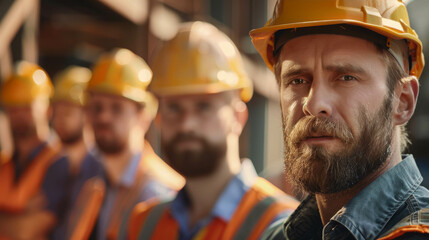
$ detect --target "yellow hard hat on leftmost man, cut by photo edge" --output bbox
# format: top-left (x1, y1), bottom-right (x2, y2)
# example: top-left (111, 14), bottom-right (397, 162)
top-left (0, 61), bottom-right (53, 106)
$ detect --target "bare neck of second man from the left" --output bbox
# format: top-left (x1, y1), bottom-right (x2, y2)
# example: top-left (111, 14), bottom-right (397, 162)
top-left (62, 138), bottom-right (88, 175)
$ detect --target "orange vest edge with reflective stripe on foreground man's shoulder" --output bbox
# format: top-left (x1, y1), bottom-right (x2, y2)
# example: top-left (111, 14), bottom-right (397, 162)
top-left (378, 208), bottom-right (429, 240)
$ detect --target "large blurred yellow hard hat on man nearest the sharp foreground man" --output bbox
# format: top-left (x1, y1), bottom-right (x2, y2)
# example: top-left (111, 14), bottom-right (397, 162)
top-left (150, 22), bottom-right (253, 102)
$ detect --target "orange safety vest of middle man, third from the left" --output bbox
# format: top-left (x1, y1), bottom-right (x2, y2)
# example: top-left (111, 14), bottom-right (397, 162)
top-left (67, 142), bottom-right (185, 240)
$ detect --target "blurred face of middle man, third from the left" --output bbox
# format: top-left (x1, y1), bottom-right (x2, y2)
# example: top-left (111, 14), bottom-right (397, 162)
top-left (88, 93), bottom-right (141, 154)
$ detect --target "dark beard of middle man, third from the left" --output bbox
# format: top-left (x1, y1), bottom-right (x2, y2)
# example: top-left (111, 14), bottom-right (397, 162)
top-left (94, 124), bottom-right (126, 154)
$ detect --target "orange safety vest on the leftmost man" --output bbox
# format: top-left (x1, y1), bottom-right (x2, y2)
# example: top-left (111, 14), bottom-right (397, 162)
top-left (0, 144), bottom-right (61, 212)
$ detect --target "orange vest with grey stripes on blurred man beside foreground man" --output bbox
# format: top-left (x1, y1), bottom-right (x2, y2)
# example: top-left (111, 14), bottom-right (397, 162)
top-left (129, 178), bottom-right (299, 240)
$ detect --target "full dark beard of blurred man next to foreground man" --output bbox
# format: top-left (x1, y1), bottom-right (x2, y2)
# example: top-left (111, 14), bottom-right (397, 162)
top-left (162, 133), bottom-right (226, 178)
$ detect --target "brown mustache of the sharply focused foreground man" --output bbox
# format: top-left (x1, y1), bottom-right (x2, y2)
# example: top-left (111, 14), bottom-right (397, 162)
top-left (289, 116), bottom-right (354, 144)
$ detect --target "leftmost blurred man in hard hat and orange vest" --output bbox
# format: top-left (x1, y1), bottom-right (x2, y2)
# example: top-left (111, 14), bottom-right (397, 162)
top-left (0, 61), bottom-right (68, 239)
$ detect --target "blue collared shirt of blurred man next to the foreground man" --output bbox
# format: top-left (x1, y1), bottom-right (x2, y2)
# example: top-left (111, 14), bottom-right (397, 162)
top-left (171, 159), bottom-right (290, 240)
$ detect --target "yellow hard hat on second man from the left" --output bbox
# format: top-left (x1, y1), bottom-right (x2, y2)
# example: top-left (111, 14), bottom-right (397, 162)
top-left (52, 66), bottom-right (91, 106)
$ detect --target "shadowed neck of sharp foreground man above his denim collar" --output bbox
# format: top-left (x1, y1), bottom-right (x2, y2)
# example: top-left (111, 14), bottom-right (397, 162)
top-left (316, 144), bottom-right (402, 225)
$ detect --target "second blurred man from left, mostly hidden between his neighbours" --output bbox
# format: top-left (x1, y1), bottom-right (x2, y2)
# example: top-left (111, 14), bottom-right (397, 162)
top-left (51, 66), bottom-right (104, 239)
